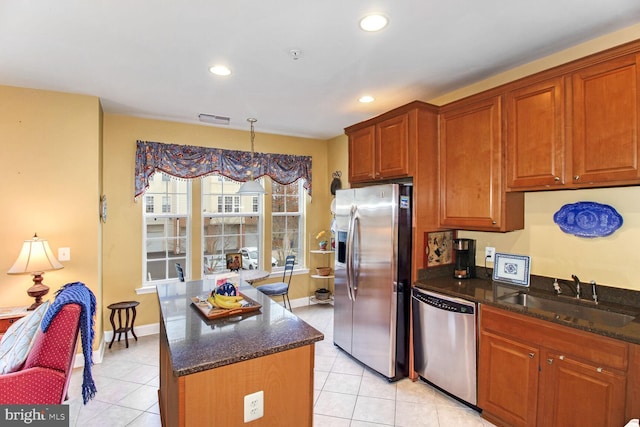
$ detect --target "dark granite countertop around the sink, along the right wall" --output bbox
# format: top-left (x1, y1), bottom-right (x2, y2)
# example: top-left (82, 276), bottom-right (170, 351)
top-left (414, 268), bottom-right (640, 344)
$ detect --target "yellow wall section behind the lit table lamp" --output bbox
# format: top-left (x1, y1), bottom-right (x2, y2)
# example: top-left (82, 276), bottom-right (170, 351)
top-left (0, 86), bottom-right (102, 342)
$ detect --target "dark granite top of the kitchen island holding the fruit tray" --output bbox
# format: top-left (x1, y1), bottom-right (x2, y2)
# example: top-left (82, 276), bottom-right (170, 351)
top-left (157, 280), bottom-right (324, 376)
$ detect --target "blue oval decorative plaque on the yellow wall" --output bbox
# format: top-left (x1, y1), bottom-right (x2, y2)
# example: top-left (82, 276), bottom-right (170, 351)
top-left (553, 202), bottom-right (622, 237)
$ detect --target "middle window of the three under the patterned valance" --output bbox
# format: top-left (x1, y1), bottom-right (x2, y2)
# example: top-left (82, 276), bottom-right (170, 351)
top-left (202, 175), bottom-right (263, 274)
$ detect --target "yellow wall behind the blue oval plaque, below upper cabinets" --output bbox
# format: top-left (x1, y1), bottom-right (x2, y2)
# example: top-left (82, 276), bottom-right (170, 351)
top-left (459, 187), bottom-right (640, 291)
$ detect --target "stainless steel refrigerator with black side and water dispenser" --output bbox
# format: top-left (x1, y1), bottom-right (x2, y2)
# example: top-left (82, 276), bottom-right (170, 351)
top-left (333, 184), bottom-right (412, 381)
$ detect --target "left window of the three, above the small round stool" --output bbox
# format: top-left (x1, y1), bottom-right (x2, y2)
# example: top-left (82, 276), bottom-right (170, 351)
top-left (143, 172), bottom-right (191, 283)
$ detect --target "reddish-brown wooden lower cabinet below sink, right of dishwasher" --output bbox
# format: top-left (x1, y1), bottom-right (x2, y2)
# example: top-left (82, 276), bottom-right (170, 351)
top-left (478, 306), bottom-right (637, 427)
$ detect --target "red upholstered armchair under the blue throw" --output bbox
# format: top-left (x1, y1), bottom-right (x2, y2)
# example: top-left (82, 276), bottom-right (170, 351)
top-left (0, 304), bottom-right (80, 405)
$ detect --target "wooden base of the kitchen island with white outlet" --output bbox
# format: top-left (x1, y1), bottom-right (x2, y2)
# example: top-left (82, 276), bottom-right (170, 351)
top-left (158, 332), bottom-right (314, 427)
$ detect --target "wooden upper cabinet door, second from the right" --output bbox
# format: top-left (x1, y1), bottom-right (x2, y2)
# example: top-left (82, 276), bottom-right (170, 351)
top-left (506, 77), bottom-right (566, 191)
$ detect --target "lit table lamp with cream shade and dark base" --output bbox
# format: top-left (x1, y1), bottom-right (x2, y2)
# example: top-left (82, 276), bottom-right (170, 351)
top-left (7, 234), bottom-right (64, 310)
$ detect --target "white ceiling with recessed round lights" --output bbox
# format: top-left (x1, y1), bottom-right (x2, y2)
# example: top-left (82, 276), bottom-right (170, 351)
top-left (0, 0), bottom-right (640, 139)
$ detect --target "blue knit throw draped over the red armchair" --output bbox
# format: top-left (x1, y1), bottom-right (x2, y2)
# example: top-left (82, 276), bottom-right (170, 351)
top-left (41, 282), bottom-right (97, 405)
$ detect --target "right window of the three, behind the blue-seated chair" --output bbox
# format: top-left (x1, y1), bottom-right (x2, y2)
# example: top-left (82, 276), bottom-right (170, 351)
top-left (271, 179), bottom-right (305, 267)
